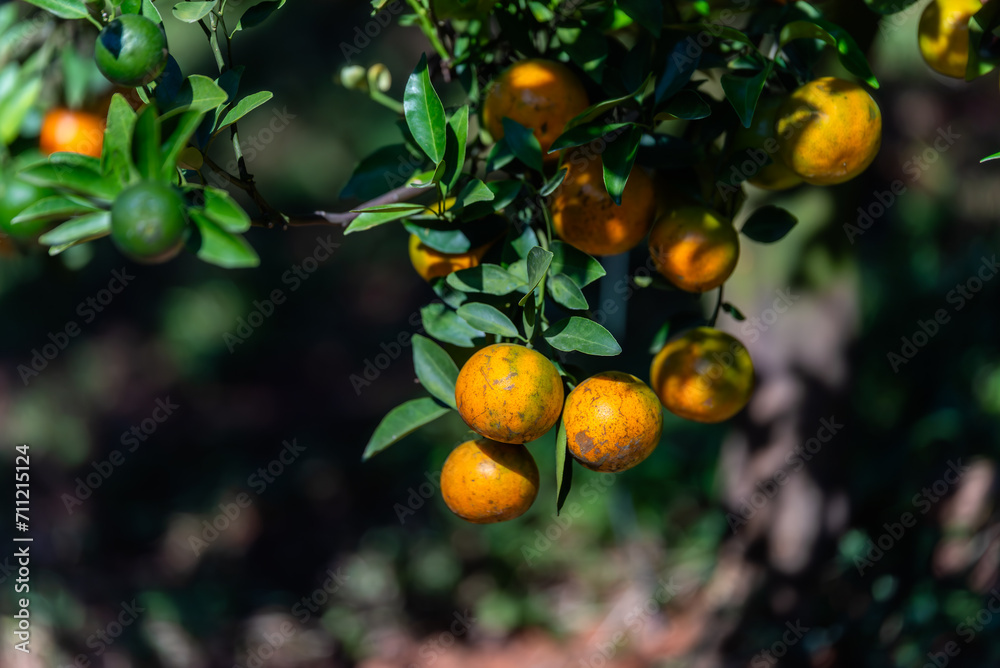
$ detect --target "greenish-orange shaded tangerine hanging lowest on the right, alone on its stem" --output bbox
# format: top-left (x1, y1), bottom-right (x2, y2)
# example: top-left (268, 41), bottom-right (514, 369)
top-left (649, 327), bottom-right (754, 422)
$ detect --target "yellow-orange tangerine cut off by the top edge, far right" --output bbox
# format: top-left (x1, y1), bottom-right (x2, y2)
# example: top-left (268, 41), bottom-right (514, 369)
top-left (917, 0), bottom-right (983, 79)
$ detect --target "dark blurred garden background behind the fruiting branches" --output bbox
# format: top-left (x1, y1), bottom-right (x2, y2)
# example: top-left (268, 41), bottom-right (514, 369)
top-left (0, 0), bottom-right (1000, 668)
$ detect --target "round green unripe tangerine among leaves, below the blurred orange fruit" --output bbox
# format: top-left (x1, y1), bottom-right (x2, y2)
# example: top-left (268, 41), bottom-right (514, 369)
top-left (111, 181), bottom-right (187, 264)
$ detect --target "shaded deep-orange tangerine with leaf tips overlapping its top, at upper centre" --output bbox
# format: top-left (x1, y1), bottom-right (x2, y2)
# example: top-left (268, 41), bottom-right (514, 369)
top-left (549, 150), bottom-right (657, 255)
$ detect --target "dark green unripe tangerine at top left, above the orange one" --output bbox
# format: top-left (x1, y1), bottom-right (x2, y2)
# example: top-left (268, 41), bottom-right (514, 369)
top-left (94, 14), bottom-right (168, 88)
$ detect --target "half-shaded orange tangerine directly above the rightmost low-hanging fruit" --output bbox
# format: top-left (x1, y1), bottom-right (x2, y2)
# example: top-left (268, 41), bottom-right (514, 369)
top-left (649, 205), bottom-right (740, 292)
